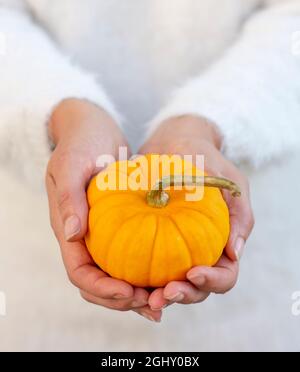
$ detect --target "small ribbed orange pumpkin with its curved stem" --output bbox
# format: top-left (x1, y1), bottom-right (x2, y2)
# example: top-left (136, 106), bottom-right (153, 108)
top-left (85, 155), bottom-right (240, 287)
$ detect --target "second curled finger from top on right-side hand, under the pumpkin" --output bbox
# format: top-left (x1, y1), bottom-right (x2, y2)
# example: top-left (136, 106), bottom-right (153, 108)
top-left (164, 282), bottom-right (209, 305)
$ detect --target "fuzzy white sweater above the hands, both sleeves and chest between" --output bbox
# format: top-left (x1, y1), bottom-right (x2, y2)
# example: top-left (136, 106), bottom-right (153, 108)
top-left (0, 0), bottom-right (300, 185)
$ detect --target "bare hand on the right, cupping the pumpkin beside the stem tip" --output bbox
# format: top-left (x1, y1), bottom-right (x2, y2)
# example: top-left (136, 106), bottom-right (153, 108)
top-left (140, 116), bottom-right (254, 310)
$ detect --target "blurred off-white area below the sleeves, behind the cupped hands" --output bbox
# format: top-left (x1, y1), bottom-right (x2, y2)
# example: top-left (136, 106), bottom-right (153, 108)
top-left (0, 152), bottom-right (300, 351)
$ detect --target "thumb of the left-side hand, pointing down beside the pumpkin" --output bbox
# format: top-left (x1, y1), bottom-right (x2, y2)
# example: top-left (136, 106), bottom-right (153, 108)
top-left (49, 153), bottom-right (92, 241)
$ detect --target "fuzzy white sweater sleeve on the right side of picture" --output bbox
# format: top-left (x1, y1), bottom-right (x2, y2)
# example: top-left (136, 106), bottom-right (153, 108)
top-left (151, 1), bottom-right (300, 167)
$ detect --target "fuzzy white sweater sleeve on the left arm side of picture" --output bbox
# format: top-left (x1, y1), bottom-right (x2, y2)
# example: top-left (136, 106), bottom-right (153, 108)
top-left (0, 4), bottom-right (119, 185)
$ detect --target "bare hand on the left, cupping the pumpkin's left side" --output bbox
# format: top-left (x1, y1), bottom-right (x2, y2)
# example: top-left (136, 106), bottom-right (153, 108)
top-left (46, 99), bottom-right (161, 321)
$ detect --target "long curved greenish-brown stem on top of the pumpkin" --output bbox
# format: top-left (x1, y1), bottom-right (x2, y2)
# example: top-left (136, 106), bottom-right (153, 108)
top-left (147, 176), bottom-right (242, 208)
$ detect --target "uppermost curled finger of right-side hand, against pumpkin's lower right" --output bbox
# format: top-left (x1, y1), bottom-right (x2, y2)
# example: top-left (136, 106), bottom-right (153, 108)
top-left (187, 256), bottom-right (239, 294)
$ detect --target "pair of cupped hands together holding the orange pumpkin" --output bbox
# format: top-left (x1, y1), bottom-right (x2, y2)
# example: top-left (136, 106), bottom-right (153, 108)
top-left (46, 99), bottom-right (254, 322)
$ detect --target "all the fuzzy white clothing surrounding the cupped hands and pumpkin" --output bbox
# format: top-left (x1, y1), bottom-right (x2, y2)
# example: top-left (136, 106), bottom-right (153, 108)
top-left (0, 0), bottom-right (300, 351)
